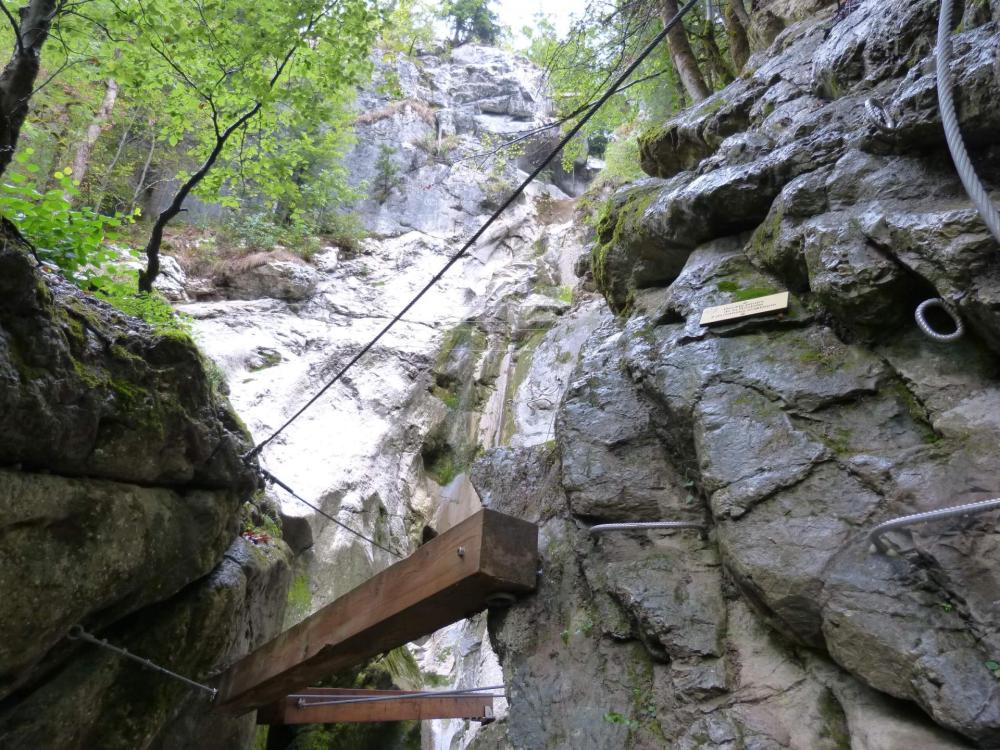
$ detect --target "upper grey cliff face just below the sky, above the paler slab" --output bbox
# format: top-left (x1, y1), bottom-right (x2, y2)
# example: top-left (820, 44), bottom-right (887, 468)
top-left (345, 45), bottom-right (564, 237)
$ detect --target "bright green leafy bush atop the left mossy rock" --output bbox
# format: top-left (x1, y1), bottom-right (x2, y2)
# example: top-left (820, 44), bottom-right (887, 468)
top-left (0, 148), bottom-right (131, 287)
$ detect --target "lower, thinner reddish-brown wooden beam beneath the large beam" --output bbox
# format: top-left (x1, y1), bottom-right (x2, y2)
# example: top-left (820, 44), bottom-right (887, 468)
top-left (257, 688), bottom-right (493, 726)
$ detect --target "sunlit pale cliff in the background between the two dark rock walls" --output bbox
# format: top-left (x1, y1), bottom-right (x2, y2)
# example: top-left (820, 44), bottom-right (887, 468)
top-left (177, 39), bottom-right (592, 750)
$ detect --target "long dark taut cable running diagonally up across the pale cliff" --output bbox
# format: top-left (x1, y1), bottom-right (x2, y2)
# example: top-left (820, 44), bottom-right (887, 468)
top-left (243, 0), bottom-right (700, 463)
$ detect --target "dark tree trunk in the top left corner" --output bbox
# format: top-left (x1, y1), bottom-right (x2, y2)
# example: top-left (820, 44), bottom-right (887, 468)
top-left (0, 0), bottom-right (58, 180)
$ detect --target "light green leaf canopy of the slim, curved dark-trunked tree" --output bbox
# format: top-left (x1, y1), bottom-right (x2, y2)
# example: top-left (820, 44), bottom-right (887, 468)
top-left (107, 0), bottom-right (380, 221)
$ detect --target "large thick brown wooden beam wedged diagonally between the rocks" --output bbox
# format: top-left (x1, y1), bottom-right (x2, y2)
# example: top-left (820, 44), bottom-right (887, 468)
top-left (218, 509), bottom-right (538, 714)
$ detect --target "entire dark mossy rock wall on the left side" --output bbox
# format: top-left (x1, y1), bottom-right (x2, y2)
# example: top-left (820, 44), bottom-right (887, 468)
top-left (0, 242), bottom-right (289, 750)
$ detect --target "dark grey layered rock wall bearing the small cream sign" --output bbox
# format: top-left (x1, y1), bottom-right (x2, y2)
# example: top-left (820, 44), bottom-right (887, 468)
top-left (473, 0), bottom-right (1000, 750)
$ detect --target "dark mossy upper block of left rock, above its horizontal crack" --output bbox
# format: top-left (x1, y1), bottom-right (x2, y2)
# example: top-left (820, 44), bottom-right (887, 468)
top-left (0, 246), bottom-right (255, 491)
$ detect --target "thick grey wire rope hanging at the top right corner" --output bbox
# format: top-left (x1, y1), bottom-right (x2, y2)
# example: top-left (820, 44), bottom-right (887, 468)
top-left (934, 0), bottom-right (1000, 242)
